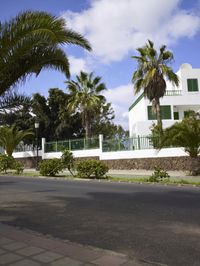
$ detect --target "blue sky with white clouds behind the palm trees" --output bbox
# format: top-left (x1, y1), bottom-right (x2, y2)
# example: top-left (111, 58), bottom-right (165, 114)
top-left (0, 0), bottom-right (200, 129)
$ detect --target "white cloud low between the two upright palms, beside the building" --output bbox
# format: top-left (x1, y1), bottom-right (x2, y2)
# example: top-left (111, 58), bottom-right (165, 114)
top-left (104, 84), bottom-right (134, 129)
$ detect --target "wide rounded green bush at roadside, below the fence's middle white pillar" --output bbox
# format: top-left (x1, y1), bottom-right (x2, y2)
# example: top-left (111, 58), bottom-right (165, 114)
top-left (76, 160), bottom-right (109, 179)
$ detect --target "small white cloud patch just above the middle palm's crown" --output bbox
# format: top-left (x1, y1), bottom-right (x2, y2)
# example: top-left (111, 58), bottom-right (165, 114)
top-left (68, 56), bottom-right (90, 75)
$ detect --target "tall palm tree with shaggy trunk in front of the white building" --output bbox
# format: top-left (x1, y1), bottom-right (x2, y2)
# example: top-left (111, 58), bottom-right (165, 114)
top-left (132, 40), bottom-right (179, 130)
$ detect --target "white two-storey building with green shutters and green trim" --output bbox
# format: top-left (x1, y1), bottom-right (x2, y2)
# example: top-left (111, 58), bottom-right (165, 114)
top-left (129, 64), bottom-right (200, 137)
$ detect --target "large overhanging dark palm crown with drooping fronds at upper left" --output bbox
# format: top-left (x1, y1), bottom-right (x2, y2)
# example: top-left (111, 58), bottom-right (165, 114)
top-left (0, 11), bottom-right (91, 95)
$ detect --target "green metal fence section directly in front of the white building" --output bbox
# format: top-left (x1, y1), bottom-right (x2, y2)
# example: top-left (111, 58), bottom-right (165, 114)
top-left (102, 136), bottom-right (159, 152)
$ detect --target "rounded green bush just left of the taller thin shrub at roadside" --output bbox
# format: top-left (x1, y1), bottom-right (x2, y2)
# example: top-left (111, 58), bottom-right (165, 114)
top-left (39, 158), bottom-right (63, 176)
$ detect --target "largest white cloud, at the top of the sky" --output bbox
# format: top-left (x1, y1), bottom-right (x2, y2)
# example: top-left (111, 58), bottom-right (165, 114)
top-left (62, 0), bottom-right (200, 62)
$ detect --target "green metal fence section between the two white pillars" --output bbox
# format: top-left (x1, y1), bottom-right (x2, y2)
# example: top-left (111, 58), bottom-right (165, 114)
top-left (44, 138), bottom-right (99, 152)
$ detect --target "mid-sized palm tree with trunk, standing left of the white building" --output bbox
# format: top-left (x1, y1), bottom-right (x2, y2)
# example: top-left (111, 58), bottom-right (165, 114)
top-left (66, 71), bottom-right (106, 138)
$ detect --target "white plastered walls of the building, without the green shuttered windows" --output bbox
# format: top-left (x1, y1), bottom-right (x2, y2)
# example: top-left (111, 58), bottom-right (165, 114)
top-left (129, 64), bottom-right (200, 137)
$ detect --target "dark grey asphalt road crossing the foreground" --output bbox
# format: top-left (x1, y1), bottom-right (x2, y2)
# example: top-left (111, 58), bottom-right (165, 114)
top-left (0, 177), bottom-right (200, 266)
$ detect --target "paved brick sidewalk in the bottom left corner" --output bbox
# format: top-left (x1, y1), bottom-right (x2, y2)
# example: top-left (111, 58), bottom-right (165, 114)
top-left (0, 223), bottom-right (142, 266)
